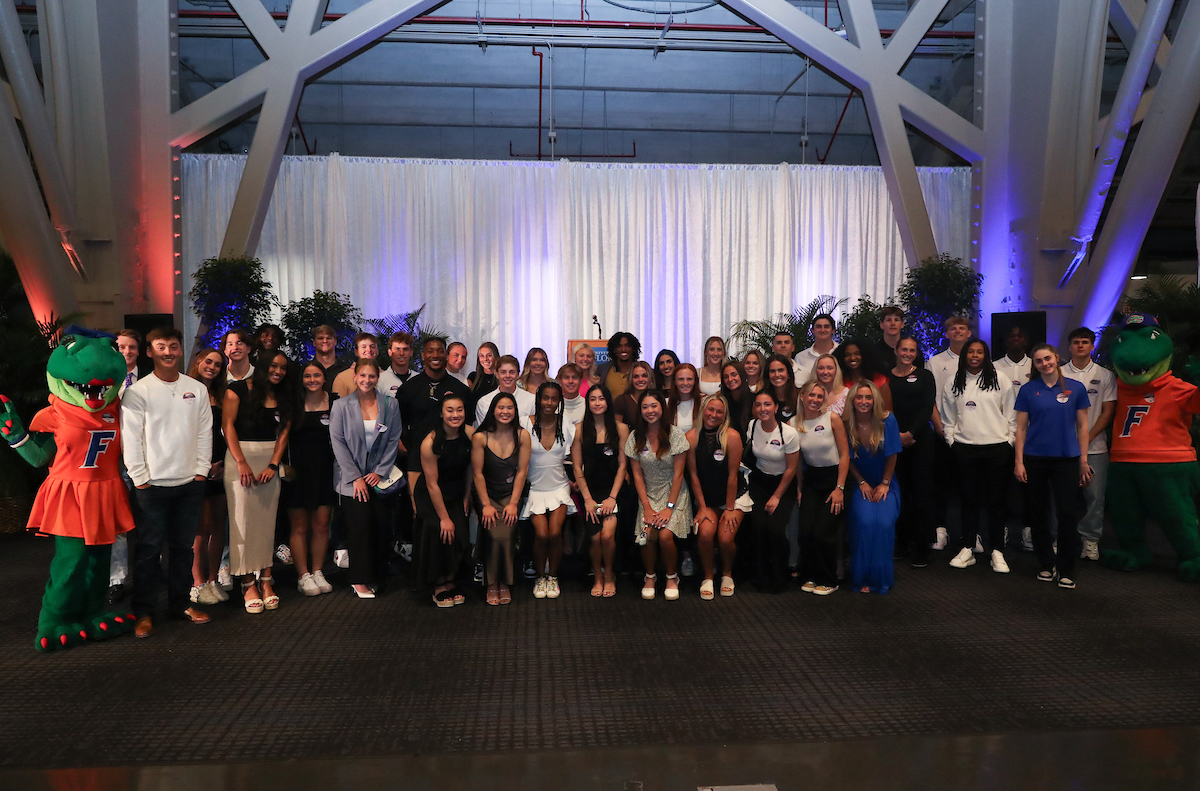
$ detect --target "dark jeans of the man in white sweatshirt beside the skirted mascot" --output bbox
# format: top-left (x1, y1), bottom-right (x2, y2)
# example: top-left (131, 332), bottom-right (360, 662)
top-left (131, 480), bottom-right (204, 617)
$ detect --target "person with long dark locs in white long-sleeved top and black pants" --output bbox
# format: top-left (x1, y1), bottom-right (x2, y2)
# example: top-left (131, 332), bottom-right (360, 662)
top-left (937, 337), bottom-right (1016, 574)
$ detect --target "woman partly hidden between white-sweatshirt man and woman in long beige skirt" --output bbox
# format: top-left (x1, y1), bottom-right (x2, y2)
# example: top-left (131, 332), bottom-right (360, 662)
top-left (187, 349), bottom-right (229, 604)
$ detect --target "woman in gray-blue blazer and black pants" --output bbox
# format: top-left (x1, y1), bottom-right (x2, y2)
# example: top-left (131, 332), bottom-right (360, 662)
top-left (329, 359), bottom-right (400, 599)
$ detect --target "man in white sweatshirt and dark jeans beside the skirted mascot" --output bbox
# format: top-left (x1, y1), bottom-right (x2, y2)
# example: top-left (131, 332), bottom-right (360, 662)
top-left (121, 328), bottom-right (212, 637)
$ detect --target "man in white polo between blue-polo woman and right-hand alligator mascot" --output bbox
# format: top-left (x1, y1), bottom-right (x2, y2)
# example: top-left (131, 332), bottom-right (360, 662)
top-left (1062, 326), bottom-right (1117, 561)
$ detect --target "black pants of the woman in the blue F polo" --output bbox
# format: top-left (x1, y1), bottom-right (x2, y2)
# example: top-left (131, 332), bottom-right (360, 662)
top-left (1025, 456), bottom-right (1087, 577)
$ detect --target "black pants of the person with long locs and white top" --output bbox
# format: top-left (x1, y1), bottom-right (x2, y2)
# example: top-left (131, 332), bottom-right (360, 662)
top-left (955, 442), bottom-right (1013, 552)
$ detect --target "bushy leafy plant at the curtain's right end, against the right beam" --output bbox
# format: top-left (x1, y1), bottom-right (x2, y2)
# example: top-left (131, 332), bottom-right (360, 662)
top-left (896, 253), bottom-right (983, 352)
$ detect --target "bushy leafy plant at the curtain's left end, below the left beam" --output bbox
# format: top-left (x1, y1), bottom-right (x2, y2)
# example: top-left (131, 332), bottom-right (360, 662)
top-left (187, 256), bottom-right (280, 347)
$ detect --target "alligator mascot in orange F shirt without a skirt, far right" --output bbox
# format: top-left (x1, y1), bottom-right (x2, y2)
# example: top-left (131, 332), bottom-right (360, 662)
top-left (1100, 313), bottom-right (1200, 582)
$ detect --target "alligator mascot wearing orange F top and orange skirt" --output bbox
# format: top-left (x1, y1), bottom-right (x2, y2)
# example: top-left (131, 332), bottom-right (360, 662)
top-left (0, 326), bottom-right (134, 651)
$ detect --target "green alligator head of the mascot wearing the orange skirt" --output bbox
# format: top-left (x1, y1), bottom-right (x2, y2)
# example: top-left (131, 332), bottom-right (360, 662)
top-left (46, 326), bottom-right (125, 412)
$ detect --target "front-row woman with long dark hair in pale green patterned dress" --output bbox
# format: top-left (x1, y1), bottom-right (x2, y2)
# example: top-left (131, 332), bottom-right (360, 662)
top-left (625, 390), bottom-right (691, 601)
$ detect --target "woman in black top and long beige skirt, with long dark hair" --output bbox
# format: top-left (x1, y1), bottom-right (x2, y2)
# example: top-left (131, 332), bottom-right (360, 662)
top-left (221, 352), bottom-right (294, 613)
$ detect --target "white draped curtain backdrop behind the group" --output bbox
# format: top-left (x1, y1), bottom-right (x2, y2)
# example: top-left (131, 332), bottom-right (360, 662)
top-left (182, 154), bottom-right (971, 367)
